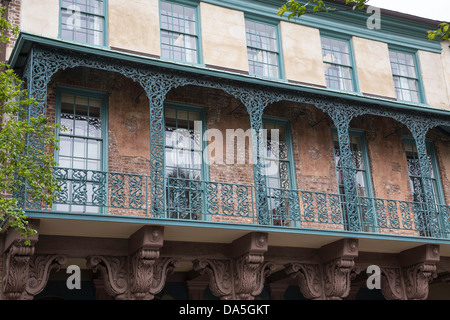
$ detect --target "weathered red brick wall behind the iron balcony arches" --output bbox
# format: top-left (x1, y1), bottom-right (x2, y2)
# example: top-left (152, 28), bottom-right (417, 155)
top-left (44, 68), bottom-right (450, 232)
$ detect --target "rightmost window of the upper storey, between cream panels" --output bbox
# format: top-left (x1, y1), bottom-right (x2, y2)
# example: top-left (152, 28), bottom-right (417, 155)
top-left (389, 50), bottom-right (422, 103)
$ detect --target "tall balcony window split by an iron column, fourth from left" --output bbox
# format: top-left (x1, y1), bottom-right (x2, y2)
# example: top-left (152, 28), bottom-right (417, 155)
top-left (333, 130), bottom-right (375, 231)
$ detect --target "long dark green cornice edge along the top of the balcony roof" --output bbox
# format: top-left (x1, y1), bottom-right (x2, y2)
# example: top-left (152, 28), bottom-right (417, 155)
top-left (9, 32), bottom-right (450, 116)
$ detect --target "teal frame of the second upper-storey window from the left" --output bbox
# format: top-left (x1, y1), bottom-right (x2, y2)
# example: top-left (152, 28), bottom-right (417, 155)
top-left (158, 0), bottom-right (203, 66)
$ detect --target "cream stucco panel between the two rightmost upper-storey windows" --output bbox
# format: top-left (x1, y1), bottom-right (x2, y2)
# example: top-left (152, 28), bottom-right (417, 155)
top-left (352, 37), bottom-right (396, 98)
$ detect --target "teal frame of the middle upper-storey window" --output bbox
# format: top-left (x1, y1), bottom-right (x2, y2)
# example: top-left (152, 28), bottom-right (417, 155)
top-left (244, 13), bottom-right (285, 81)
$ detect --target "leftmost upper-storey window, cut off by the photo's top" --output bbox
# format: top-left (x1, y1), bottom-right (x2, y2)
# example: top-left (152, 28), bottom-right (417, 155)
top-left (60, 0), bottom-right (106, 46)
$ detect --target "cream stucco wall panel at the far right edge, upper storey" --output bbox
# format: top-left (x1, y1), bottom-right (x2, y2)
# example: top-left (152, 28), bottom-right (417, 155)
top-left (418, 51), bottom-right (450, 109)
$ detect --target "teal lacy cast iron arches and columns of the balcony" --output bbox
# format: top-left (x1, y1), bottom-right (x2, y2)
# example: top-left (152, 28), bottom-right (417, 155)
top-left (23, 45), bottom-right (450, 235)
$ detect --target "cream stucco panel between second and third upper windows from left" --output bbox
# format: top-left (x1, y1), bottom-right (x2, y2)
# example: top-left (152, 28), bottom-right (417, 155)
top-left (200, 2), bottom-right (249, 72)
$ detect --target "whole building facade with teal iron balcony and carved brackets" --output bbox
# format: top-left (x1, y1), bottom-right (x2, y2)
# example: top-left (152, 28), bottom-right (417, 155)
top-left (0, 0), bottom-right (450, 300)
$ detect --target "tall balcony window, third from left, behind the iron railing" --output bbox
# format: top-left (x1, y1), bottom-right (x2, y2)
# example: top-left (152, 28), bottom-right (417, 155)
top-left (263, 119), bottom-right (298, 225)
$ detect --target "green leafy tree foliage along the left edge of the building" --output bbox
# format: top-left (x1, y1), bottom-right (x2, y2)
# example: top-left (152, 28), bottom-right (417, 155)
top-left (0, 8), bottom-right (59, 244)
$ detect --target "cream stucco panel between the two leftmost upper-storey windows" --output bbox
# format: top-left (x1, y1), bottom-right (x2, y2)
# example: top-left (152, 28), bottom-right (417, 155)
top-left (108, 0), bottom-right (161, 56)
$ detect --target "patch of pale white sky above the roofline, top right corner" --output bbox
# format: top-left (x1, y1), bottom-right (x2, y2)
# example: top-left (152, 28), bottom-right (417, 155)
top-left (367, 0), bottom-right (450, 22)
